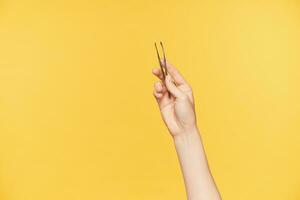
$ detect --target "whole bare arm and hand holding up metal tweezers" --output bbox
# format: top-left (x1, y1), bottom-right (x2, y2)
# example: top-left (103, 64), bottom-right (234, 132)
top-left (152, 63), bottom-right (221, 200)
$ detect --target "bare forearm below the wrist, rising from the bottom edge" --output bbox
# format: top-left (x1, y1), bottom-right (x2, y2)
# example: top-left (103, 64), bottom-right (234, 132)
top-left (174, 130), bottom-right (221, 200)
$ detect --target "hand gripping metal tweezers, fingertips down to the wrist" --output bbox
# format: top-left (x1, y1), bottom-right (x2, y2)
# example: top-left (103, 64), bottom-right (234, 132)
top-left (152, 63), bottom-right (197, 137)
